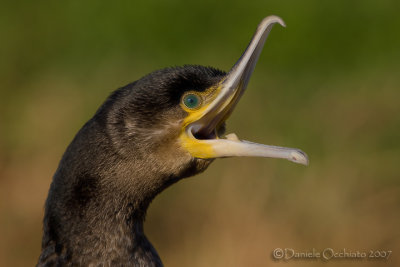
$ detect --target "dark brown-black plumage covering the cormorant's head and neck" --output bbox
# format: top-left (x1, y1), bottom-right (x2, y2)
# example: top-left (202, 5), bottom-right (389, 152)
top-left (39, 66), bottom-right (225, 266)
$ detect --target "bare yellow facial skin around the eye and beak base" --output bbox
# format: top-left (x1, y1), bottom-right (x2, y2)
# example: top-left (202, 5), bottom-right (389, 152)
top-left (179, 86), bottom-right (221, 159)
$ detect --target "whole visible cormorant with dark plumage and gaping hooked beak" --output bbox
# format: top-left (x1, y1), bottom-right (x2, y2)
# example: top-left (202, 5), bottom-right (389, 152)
top-left (38, 16), bottom-right (308, 266)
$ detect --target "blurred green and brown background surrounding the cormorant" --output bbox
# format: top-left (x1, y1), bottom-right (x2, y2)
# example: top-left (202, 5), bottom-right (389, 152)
top-left (0, 0), bottom-right (400, 266)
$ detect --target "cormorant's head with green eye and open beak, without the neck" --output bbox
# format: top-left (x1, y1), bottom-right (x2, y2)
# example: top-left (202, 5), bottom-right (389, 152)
top-left (98, 16), bottom-right (308, 181)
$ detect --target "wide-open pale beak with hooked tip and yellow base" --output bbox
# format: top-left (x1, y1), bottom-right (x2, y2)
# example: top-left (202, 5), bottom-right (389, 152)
top-left (182, 16), bottom-right (308, 165)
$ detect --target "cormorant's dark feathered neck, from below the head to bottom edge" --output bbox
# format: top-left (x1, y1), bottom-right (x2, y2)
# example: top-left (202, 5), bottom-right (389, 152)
top-left (39, 120), bottom-right (185, 266)
